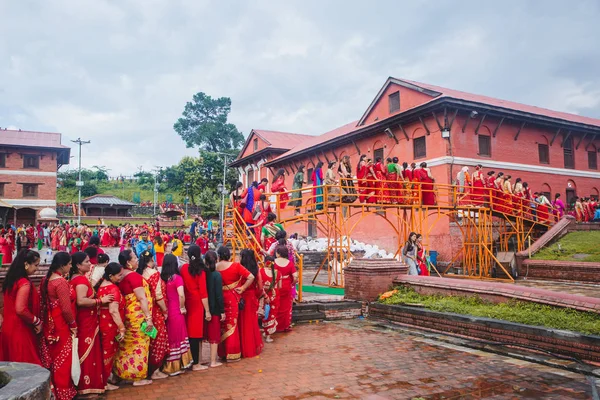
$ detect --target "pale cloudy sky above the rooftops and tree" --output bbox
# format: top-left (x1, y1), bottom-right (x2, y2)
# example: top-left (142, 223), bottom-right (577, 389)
top-left (0, 0), bottom-right (600, 175)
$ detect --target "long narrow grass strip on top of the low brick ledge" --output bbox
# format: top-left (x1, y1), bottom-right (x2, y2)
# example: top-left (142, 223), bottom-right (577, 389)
top-left (379, 287), bottom-right (600, 335)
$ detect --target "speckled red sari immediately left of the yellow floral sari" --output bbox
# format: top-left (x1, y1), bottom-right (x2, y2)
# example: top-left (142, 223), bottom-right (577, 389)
top-left (97, 283), bottom-right (125, 387)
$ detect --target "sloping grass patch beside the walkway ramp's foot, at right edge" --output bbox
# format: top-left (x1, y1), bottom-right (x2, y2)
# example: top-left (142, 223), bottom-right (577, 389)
top-left (531, 231), bottom-right (600, 262)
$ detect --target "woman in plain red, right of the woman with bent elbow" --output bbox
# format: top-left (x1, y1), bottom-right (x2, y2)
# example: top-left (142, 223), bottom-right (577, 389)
top-left (239, 249), bottom-right (264, 358)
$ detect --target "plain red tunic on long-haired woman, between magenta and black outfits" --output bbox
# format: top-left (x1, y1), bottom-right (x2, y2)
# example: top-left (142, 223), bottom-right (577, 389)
top-left (180, 264), bottom-right (208, 339)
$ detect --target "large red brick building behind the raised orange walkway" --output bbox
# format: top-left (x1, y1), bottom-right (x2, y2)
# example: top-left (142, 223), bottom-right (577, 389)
top-left (235, 78), bottom-right (600, 258)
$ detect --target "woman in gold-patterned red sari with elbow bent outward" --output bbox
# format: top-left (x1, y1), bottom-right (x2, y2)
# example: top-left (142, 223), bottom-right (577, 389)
top-left (217, 246), bottom-right (254, 362)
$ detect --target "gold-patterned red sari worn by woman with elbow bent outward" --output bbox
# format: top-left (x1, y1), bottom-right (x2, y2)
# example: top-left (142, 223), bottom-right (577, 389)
top-left (219, 262), bottom-right (250, 361)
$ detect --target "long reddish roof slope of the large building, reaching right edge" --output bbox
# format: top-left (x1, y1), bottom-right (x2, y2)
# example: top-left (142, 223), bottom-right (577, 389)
top-left (400, 78), bottom-right (600, 131)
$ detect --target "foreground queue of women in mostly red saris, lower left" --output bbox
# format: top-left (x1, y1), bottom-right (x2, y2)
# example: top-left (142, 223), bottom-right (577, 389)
top-left (0, 233), bottom-right (297, 400)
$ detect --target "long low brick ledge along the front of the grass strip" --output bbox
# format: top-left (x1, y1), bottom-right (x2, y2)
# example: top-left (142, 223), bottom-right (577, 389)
top-left (369, 303), bottom-right (600, 363)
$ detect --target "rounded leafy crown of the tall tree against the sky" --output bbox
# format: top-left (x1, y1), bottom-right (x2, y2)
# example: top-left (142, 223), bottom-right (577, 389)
top-left (173, 92), bottom-right (244, 152)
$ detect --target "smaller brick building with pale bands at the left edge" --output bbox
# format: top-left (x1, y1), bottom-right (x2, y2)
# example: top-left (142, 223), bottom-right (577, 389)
top-left (0, 129), bottom-right (71, 224)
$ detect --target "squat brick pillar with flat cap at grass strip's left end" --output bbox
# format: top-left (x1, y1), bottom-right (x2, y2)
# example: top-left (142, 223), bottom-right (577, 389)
top-left (344, 259), bottom-right (408, 301)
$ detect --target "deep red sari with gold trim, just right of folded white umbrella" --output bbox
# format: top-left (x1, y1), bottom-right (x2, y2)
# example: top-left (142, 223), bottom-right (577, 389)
top-left (70, 276), bottom-right (106, 395)
